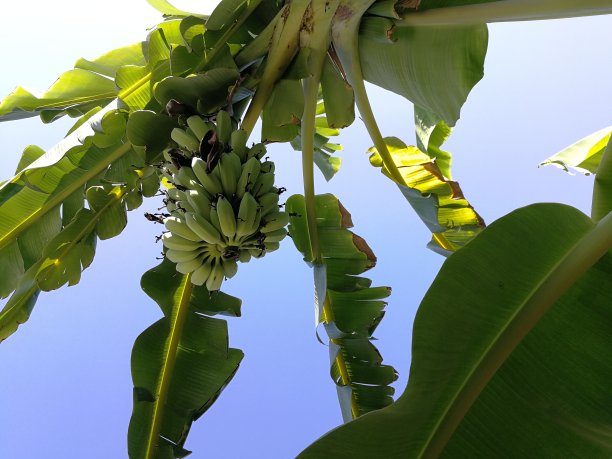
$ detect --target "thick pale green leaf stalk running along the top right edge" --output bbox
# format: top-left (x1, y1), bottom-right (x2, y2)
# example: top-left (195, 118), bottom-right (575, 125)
top-left (395, 0), bottom-right (612, 26)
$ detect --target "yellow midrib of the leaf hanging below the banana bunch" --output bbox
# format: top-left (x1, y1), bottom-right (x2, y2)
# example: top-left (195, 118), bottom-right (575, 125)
top-left (145, 274), bottom-right (193, 459)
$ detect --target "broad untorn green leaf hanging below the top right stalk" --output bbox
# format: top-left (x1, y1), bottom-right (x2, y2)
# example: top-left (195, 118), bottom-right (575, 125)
top-left (359, 18), bottom-right (488, 126)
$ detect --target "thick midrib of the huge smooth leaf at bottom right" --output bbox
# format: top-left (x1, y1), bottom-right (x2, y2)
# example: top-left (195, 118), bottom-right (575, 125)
top-left (415, 212), bottom-right (612, 458)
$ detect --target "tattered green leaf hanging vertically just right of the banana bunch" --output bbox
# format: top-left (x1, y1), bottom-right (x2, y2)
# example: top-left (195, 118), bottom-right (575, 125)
top-left (286, 194), bottom-right (397, 421)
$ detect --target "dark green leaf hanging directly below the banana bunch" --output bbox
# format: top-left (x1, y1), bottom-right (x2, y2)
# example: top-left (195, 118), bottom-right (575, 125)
top-left (128, 259), bottom-right (243, 459)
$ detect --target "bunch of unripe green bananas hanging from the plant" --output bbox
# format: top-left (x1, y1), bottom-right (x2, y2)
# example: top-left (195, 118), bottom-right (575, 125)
top-left (161, 111), bottom-right (289, 291)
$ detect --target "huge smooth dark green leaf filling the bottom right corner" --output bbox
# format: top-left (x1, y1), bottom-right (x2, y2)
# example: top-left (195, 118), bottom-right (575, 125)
top-left (300, 204), bottom-right (612, 458)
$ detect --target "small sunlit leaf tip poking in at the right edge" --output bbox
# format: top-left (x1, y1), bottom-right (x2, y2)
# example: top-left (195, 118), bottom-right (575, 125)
top-left (540, 126), bottom-right (612, 175)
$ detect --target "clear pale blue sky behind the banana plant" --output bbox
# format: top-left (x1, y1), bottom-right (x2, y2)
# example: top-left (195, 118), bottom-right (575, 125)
top-left (0, 0), bottom-right (612, 459)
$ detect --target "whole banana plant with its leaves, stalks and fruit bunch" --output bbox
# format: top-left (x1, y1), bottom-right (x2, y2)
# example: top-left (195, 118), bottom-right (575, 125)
top-left (0, 0), bottom-right (612, 459)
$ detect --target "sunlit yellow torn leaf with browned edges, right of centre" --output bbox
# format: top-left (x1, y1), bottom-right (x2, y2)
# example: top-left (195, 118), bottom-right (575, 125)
top-left (369, 137), bottom-right (485, 255)
